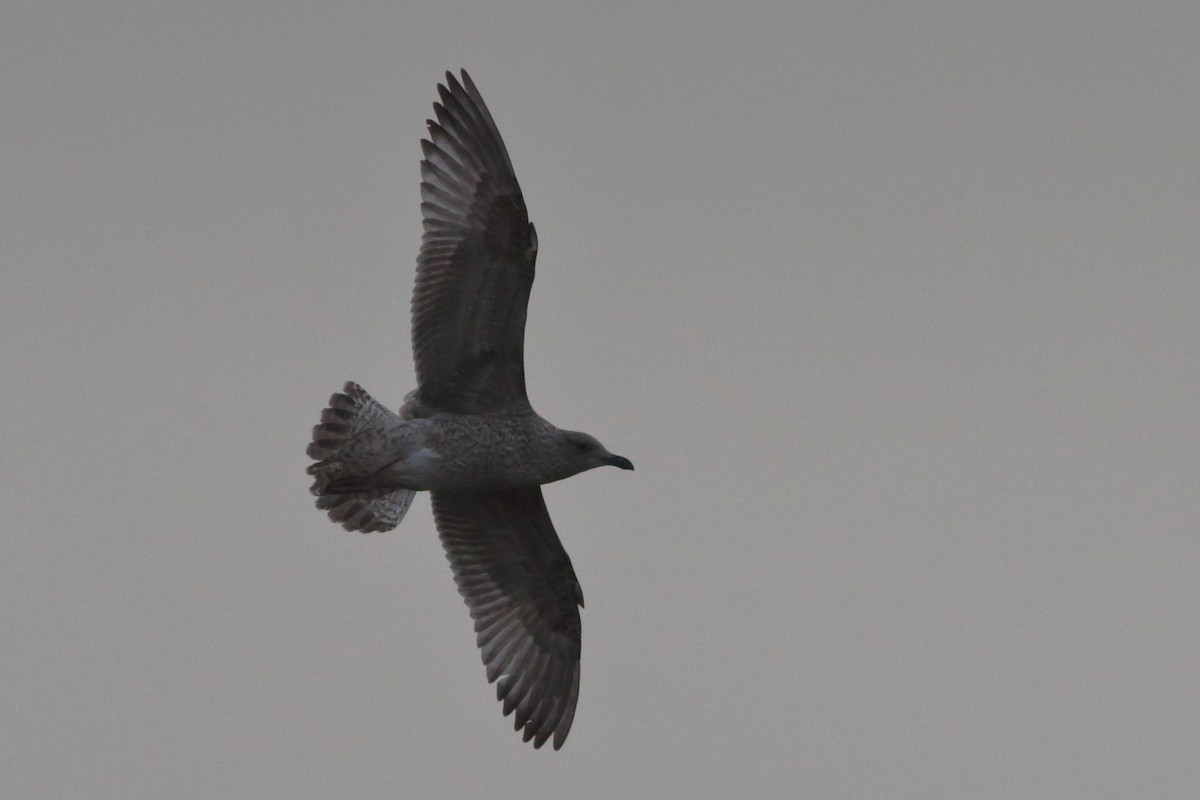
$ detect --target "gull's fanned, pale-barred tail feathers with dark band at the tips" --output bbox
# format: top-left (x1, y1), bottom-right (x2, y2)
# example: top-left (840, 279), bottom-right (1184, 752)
top-left (307, 383), bottom-right (415, 533)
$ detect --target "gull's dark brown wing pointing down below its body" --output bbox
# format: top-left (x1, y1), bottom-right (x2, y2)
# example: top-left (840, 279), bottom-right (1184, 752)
top-left (432, 487), bottom-right (583, 750)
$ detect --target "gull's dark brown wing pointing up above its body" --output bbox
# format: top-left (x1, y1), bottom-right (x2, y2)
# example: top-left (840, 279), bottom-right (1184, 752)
top-left (413, 71), bottom-right (538, 414)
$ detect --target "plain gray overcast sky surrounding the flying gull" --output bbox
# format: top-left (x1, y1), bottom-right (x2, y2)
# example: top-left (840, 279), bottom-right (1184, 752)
top-left (0, 0), bottom-right (1200, 800)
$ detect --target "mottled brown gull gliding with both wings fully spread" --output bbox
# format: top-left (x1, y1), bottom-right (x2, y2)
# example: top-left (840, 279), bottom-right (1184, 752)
top-left (307, 71), bottom-right (634, 750)
